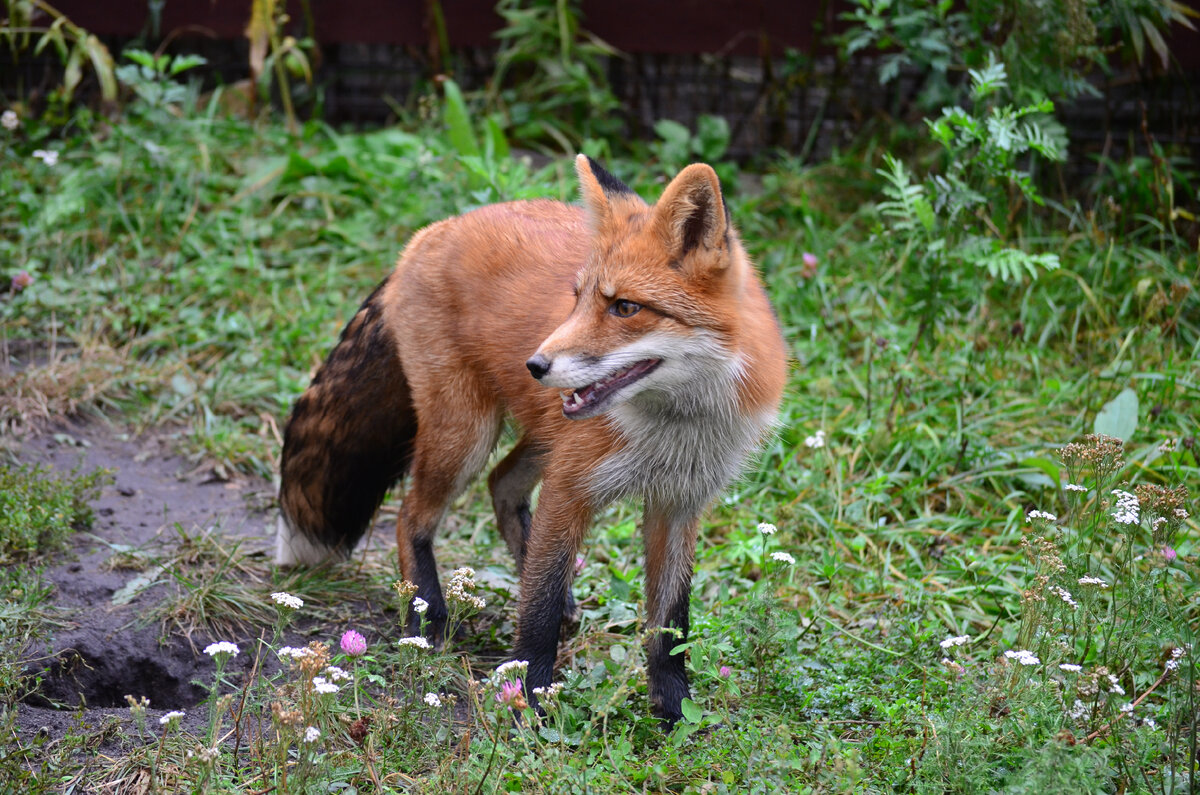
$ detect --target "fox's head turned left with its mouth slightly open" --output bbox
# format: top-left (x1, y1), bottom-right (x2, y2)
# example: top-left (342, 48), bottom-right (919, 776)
top-left (526, 155), bottom-right (749, 419)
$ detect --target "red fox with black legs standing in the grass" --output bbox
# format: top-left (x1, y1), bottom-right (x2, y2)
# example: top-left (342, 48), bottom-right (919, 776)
top-left (275, 155), bottom-right (787, 725)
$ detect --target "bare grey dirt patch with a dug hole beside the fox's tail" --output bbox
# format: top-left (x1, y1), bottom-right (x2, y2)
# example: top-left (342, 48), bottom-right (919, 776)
top-left (13, 423), bottom-right (274, 747)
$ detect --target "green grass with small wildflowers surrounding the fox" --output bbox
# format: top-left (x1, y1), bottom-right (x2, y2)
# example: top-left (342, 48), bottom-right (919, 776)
top-left (0, 63), bottom-right (1200, 793)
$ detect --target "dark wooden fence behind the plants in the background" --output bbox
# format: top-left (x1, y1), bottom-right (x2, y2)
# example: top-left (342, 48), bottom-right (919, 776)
top-left (0, 0), bottom-right (1200, 163)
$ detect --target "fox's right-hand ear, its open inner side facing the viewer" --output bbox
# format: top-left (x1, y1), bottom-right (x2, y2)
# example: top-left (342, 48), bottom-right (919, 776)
top-left (654, 163), bottom-right (728, 257)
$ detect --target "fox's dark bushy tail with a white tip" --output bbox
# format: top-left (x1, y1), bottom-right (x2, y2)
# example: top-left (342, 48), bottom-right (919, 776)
top-left (275, 281), bottom-right (416, 566)
